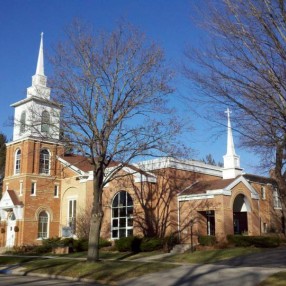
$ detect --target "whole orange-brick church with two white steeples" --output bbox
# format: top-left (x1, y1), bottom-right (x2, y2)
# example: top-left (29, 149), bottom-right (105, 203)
top-left (0, 35), bottom-right (282, 247)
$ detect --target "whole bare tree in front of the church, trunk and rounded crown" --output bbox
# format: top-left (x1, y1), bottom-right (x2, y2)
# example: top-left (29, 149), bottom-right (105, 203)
top-left (52, 22), bottom-right (185, 262)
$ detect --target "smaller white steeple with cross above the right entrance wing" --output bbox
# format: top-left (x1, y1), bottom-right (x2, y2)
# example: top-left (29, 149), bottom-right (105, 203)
top-left (222, 108), bottom-right (242, 179)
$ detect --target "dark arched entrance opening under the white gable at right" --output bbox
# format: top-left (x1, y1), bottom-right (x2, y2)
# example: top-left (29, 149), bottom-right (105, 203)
top-left (233, 194), bottom-right (251, 234)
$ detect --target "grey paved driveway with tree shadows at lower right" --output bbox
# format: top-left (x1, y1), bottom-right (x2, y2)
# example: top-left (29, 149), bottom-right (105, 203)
top-left (120, 248), bottom-right (286, 286)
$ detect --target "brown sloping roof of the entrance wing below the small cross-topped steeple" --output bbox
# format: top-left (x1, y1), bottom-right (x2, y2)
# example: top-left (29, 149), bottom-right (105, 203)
top-left (180, 178), bottom-right (236, 196)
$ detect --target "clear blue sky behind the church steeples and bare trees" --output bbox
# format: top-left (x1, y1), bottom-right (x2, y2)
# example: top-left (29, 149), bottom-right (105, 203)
top-left (0, 0), bottom-right (258, 173)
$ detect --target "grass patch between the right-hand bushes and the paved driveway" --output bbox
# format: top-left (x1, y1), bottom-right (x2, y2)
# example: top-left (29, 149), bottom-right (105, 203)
top-left (159, 247), bottom-right (263, 264)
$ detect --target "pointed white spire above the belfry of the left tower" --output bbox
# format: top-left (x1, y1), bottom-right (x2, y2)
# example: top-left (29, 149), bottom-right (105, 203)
top-left (27, 32), bottom-right (51, 100)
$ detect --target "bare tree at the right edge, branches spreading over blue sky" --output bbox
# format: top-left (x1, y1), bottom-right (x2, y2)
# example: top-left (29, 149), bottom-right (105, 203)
top-left (185, 0), bottom-right (286, 232)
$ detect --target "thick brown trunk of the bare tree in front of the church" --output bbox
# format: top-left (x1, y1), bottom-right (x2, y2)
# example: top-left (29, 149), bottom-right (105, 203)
top-left (87, 169), bottom-right (104, 262)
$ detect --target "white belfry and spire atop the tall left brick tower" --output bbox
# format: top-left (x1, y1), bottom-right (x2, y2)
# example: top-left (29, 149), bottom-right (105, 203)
top-left (11, 33), bottom-right (61, 141)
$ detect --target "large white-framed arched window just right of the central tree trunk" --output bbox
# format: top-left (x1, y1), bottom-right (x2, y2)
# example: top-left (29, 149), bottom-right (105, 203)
top-left (111, 191), bottom-right (133, 239)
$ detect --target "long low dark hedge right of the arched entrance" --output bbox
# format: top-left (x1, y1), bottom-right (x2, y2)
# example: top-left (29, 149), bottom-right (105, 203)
top-left (227, 235), bottom-right (281, 248)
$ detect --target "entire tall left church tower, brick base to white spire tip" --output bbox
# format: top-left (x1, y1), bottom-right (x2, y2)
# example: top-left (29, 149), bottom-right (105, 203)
top-left (0, 33), bottom-right (64, 247)
